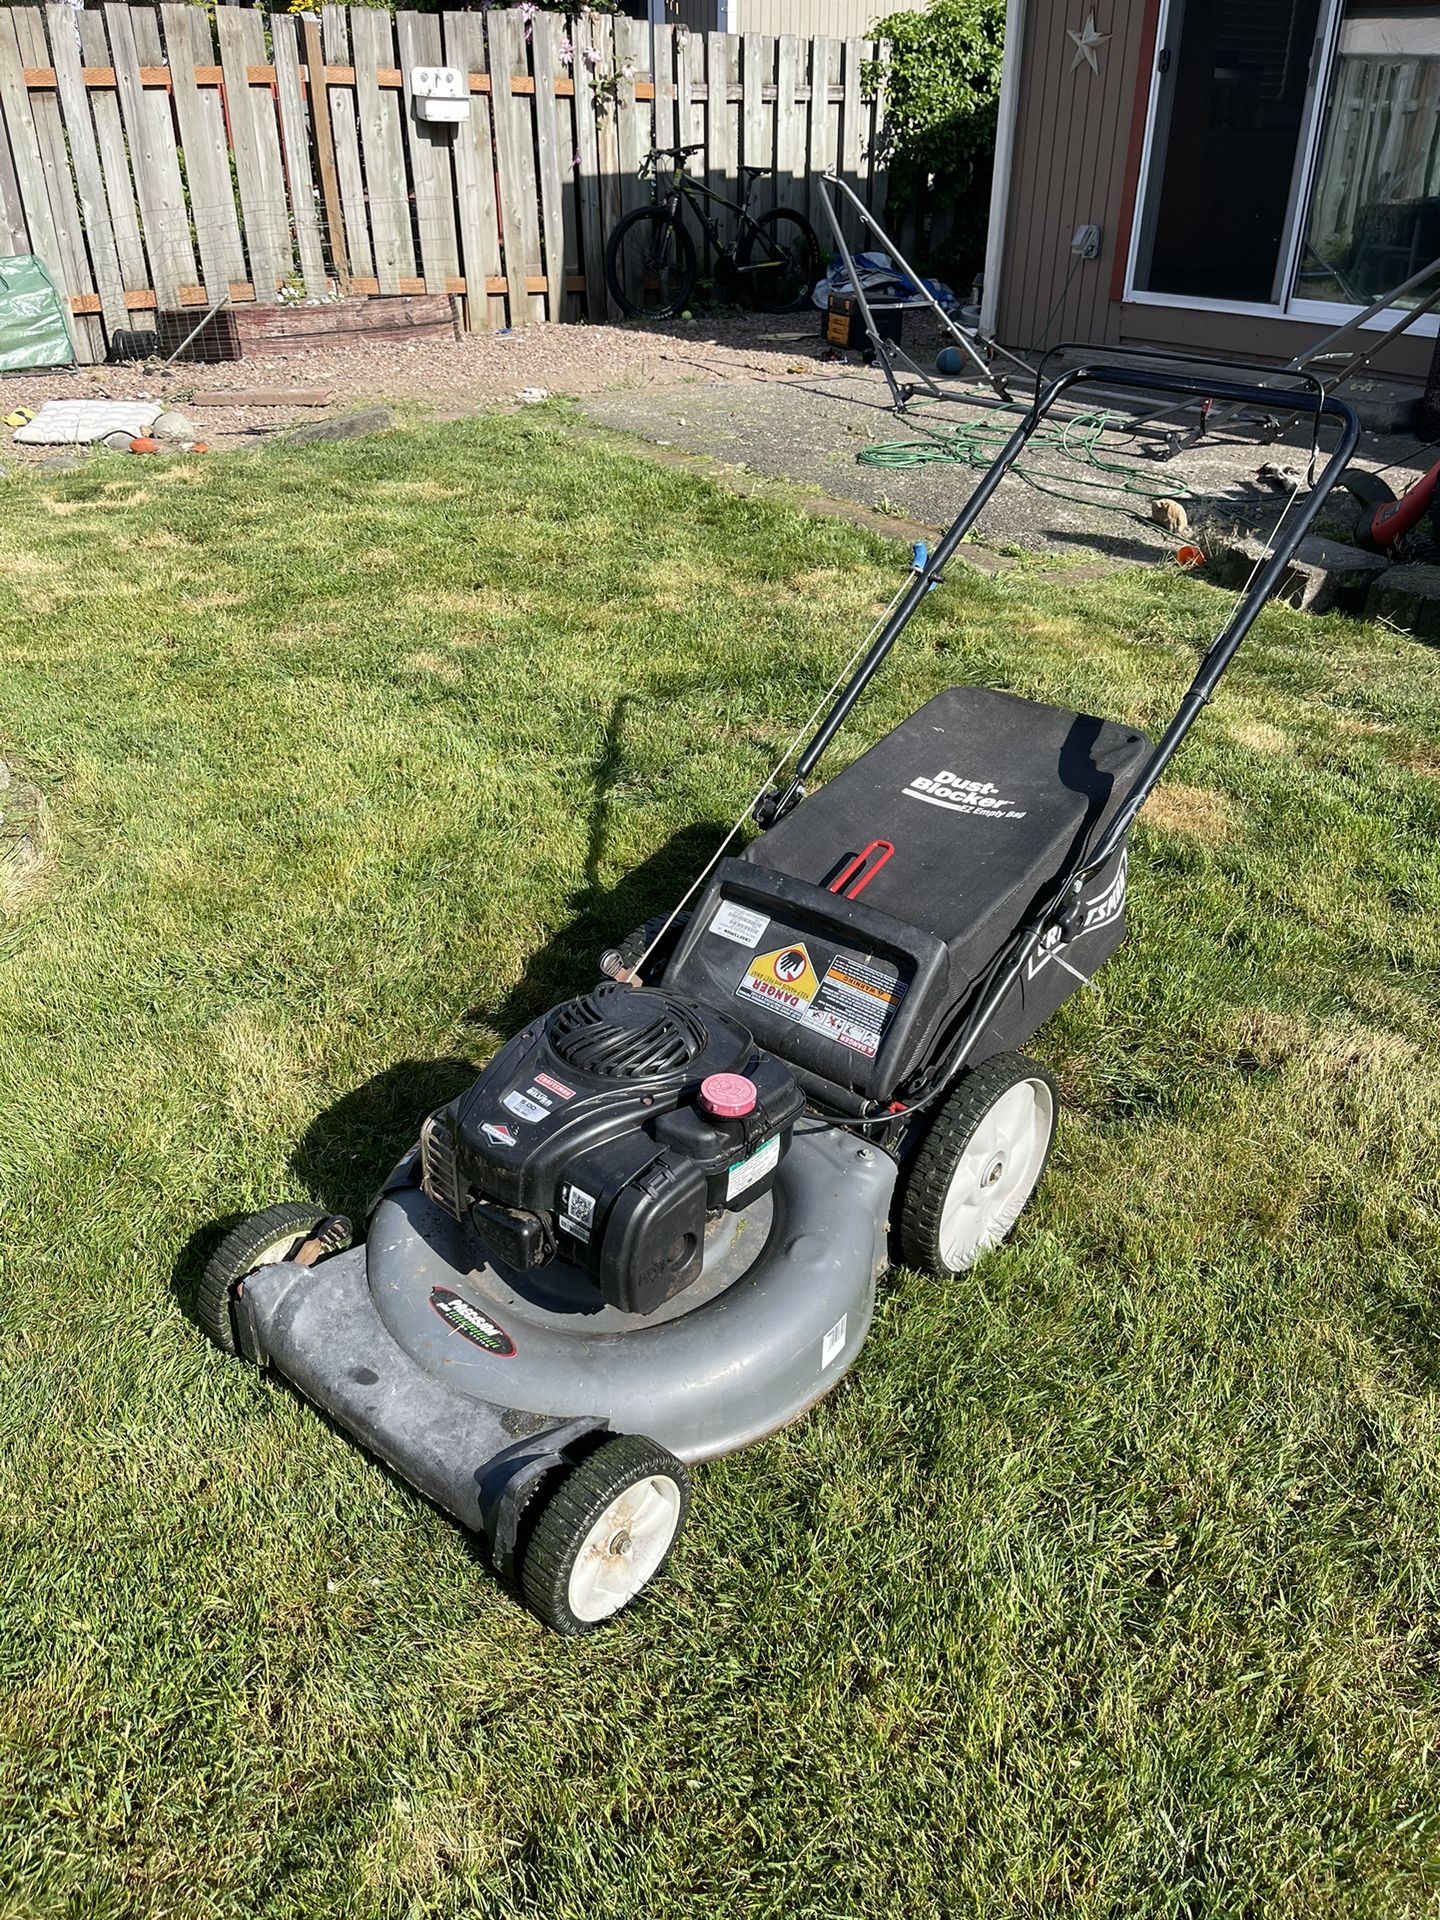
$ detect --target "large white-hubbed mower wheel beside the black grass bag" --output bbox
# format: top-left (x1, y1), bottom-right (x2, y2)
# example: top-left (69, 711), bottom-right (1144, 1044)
top-left (900, 1054), bottom-right (1060, 1273)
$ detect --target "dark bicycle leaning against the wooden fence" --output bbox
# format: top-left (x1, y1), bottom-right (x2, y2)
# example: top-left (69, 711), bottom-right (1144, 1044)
top-left (605, 146), bottom-right (822, 321)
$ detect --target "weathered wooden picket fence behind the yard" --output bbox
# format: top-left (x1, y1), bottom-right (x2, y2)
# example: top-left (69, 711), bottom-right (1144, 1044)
top-left (0, 4), bottom-right (885, 361)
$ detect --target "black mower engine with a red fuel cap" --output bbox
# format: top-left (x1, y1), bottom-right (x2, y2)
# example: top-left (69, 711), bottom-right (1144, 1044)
top-left (420, 981), bottom-right (804, 1313)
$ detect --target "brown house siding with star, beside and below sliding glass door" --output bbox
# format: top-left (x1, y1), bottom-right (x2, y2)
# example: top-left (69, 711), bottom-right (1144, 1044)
top-left (995, 0), bottom-right (1434, 380)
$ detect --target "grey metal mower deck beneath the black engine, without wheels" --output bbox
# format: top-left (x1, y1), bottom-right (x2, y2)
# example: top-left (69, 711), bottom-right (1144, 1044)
top-left (238, 1129), bottom-right (895, 1559)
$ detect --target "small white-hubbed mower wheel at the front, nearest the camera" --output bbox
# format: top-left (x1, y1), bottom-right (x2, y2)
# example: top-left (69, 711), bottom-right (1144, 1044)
top-left (520, 1434), bottom-right (689, 1634)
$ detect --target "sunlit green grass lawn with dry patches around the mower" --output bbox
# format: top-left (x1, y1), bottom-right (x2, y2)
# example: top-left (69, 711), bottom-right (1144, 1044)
top-left (0, 417), bottom-right (1440, 1920)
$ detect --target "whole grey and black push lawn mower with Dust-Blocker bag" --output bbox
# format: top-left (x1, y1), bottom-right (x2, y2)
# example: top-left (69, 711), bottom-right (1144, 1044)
top-left (196, 365), bottom-right (1357, 1634)
